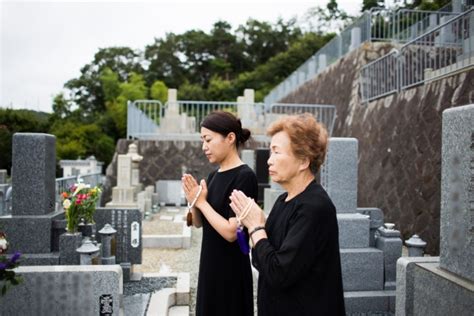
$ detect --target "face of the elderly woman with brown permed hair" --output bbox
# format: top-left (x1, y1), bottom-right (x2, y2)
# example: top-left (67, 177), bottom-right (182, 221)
top-left (267, 131), bottom-right (303, 184)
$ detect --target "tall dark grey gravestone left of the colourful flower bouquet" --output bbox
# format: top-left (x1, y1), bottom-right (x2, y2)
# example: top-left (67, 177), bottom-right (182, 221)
top-left (0, 133), bottom-right (64, 264)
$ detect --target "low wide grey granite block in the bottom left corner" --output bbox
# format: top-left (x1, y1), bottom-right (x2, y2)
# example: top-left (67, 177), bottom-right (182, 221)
top-left (0, 265), bottom-right (123, 316)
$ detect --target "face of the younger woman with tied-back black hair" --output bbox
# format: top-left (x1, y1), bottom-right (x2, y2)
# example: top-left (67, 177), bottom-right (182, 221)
top-left (201, 127), bottom-right (235, 164)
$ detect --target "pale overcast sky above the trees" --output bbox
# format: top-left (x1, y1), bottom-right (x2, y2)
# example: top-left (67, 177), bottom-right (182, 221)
top-left (0, 0), bottom-right (362, 112)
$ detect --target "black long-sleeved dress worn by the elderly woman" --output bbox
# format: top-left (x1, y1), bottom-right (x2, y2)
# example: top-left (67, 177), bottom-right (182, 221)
top-left (252, 181), bottom-right (345, 316)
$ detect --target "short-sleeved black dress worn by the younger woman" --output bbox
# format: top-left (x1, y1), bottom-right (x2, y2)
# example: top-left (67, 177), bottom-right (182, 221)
top-left (196, 165), bottom-right (258, 316)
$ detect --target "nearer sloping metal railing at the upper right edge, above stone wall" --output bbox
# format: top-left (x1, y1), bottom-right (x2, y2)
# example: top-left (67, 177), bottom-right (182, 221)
top-left (360, 9), bottom-right (474, 102)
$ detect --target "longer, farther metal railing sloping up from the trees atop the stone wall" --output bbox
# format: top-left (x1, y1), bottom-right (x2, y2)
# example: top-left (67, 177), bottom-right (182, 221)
top-left (264, 8), bottom-right (458, 104)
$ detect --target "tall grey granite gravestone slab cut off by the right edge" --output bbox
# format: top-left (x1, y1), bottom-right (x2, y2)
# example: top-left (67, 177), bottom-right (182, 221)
top-left (440, 105), bottom-right (474, 281)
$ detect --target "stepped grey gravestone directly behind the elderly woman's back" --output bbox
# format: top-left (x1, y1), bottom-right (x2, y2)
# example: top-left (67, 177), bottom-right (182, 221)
top-left (319, 137), bottom-right (402, 315)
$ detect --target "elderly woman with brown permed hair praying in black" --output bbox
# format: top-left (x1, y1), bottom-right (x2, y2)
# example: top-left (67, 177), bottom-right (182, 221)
top-left (230, 114), bottom-right (345, 316)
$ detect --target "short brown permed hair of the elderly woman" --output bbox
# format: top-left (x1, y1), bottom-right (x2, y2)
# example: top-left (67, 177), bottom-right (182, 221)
top-left (267, 113), bottom-right (328, 173)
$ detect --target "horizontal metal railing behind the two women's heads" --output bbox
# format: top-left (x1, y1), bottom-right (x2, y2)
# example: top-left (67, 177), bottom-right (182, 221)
top-left (127, 100), bottom-right (336, 141)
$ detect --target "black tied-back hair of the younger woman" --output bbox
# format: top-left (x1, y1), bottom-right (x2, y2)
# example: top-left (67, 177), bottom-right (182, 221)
top-left (201, 111), bottom-right (251, 148)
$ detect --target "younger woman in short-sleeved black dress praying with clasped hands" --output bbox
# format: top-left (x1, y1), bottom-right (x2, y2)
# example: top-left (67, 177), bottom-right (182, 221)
top-left (182, 112), bottom-right (258, 316)
